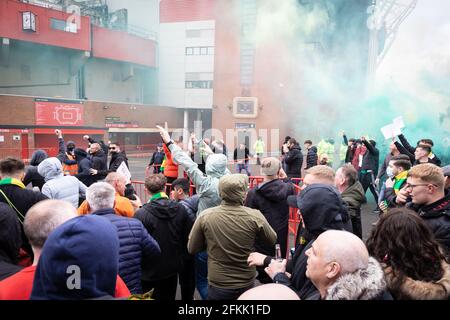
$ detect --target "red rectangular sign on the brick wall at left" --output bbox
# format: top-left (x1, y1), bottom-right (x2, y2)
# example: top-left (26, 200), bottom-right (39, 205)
top-left (35, 99), bottom-right (84, 127)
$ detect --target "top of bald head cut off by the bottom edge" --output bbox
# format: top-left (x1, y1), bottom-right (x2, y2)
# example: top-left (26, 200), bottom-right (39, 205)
top-left (238, 283), bottom-right (300, 300)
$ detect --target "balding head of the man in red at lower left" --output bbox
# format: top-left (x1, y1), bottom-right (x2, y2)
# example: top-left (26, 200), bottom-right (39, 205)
top-left (23, 200), bottom-right (77, 249)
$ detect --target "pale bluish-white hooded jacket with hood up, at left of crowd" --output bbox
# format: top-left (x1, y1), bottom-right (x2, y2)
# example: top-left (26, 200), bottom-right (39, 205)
top-left (38, 158), bottom-right (87, 208)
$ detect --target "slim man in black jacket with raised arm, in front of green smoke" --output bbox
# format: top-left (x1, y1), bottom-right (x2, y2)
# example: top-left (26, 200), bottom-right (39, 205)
top-left (359, 137), bottom-right (380, 210)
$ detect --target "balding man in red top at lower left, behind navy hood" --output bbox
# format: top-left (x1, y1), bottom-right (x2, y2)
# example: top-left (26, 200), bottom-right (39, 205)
top-left (0, 200), bottom-right (77, 300)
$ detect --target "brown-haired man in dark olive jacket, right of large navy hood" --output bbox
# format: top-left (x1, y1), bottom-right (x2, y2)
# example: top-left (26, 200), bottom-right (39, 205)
top-left (334, 163), bottom-right (367, 239)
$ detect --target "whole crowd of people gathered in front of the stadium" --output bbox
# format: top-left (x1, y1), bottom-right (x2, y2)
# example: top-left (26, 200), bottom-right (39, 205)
top-left (0, 126), bottom-right (450, 301)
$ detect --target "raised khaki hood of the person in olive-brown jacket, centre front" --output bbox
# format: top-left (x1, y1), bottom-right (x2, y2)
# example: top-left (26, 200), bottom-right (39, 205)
top-left (219, 174), bottom-right (248, 205)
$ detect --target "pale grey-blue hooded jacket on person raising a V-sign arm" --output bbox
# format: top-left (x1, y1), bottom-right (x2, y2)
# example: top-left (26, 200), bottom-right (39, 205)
top-left (169, 144), bottom-right (230, 216)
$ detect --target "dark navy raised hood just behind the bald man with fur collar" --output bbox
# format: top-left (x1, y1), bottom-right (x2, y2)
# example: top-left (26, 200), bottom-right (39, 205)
top-left (287, 184), bottom-right (349, 236)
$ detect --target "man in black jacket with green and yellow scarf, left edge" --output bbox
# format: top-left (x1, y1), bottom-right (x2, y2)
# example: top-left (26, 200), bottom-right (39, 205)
top-left (0, 158), bottom-right (48, 257)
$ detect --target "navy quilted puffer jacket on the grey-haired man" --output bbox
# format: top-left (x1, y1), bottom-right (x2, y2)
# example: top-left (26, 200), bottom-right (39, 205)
top-left (93, 209), bottom-right (161, 294)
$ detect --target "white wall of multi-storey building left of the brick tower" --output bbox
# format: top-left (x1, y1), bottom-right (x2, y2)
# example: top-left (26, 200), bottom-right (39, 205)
top-left (158, 20), bottom-right (215, 109)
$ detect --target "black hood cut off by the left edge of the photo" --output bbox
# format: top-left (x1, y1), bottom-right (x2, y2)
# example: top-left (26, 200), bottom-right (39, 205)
top-left (0, 202), bottom-right (22, 264)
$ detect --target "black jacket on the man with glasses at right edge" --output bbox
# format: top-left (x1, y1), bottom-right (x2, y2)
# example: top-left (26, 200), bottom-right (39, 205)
top-left (407, 193), bottom-right (450, 256)
